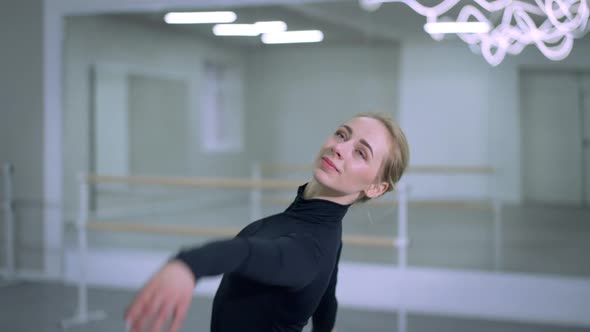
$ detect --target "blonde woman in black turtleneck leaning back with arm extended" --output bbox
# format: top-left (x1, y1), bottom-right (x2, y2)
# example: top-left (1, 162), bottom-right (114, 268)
top-left (125, 113), bottom-right (409, 332)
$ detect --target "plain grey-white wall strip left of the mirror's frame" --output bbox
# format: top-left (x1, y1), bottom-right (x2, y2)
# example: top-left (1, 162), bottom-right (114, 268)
top-left (0, 0), bottom-right (44, 271)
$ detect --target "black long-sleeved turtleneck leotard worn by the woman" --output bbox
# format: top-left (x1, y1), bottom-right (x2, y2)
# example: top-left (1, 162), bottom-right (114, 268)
top-left (176, 185), bottom-right (349, 332)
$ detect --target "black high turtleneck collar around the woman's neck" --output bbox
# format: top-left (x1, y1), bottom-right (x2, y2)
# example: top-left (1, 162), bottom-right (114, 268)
top-left (285, 183), bottom-right (350, 223)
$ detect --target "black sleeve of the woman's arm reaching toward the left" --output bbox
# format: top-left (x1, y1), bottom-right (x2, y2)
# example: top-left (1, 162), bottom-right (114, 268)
top-left (176, 234), bottom-right (323, 288)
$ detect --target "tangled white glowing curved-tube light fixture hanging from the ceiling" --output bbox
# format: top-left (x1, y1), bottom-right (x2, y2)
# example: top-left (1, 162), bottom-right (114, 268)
top-left (359, 0), bottom-right (590, 66)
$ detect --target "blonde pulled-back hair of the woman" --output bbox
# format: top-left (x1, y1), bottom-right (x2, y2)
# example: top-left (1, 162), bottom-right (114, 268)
top-left (354, 112), bottom-right (410, 203)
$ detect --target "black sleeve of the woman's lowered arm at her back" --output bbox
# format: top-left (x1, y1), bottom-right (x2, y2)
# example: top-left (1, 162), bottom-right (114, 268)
top-left (312, 243), bottom-right (342, 332)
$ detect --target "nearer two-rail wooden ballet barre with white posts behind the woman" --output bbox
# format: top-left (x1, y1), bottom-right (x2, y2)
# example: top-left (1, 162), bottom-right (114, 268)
top-left (61, 174), bottom-right (408, 329)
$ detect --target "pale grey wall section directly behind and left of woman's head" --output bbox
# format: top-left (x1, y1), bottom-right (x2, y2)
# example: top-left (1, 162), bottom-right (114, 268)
top-left (246, 45), bottom-right (398, 165)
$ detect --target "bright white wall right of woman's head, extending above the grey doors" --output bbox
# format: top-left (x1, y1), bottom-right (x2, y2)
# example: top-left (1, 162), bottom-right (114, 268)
top-left (399, 37), bottom-right (590, 202)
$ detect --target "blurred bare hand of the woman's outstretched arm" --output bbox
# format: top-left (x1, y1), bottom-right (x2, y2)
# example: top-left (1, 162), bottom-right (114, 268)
top-left (125, 261), bottom-right (196, 332)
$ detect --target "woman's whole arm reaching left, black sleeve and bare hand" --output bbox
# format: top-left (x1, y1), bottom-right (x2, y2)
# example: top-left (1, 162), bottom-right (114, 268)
top-left (125, 234), bottom-right (323, 332)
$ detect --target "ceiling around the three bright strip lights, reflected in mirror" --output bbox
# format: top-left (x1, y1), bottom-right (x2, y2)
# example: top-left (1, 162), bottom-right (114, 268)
top-left (99, 0), bottom-right (590, 47)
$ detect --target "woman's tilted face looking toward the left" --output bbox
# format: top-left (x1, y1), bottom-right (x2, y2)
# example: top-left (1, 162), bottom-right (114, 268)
top-left (313, 117), bottom-right (390, 199)
